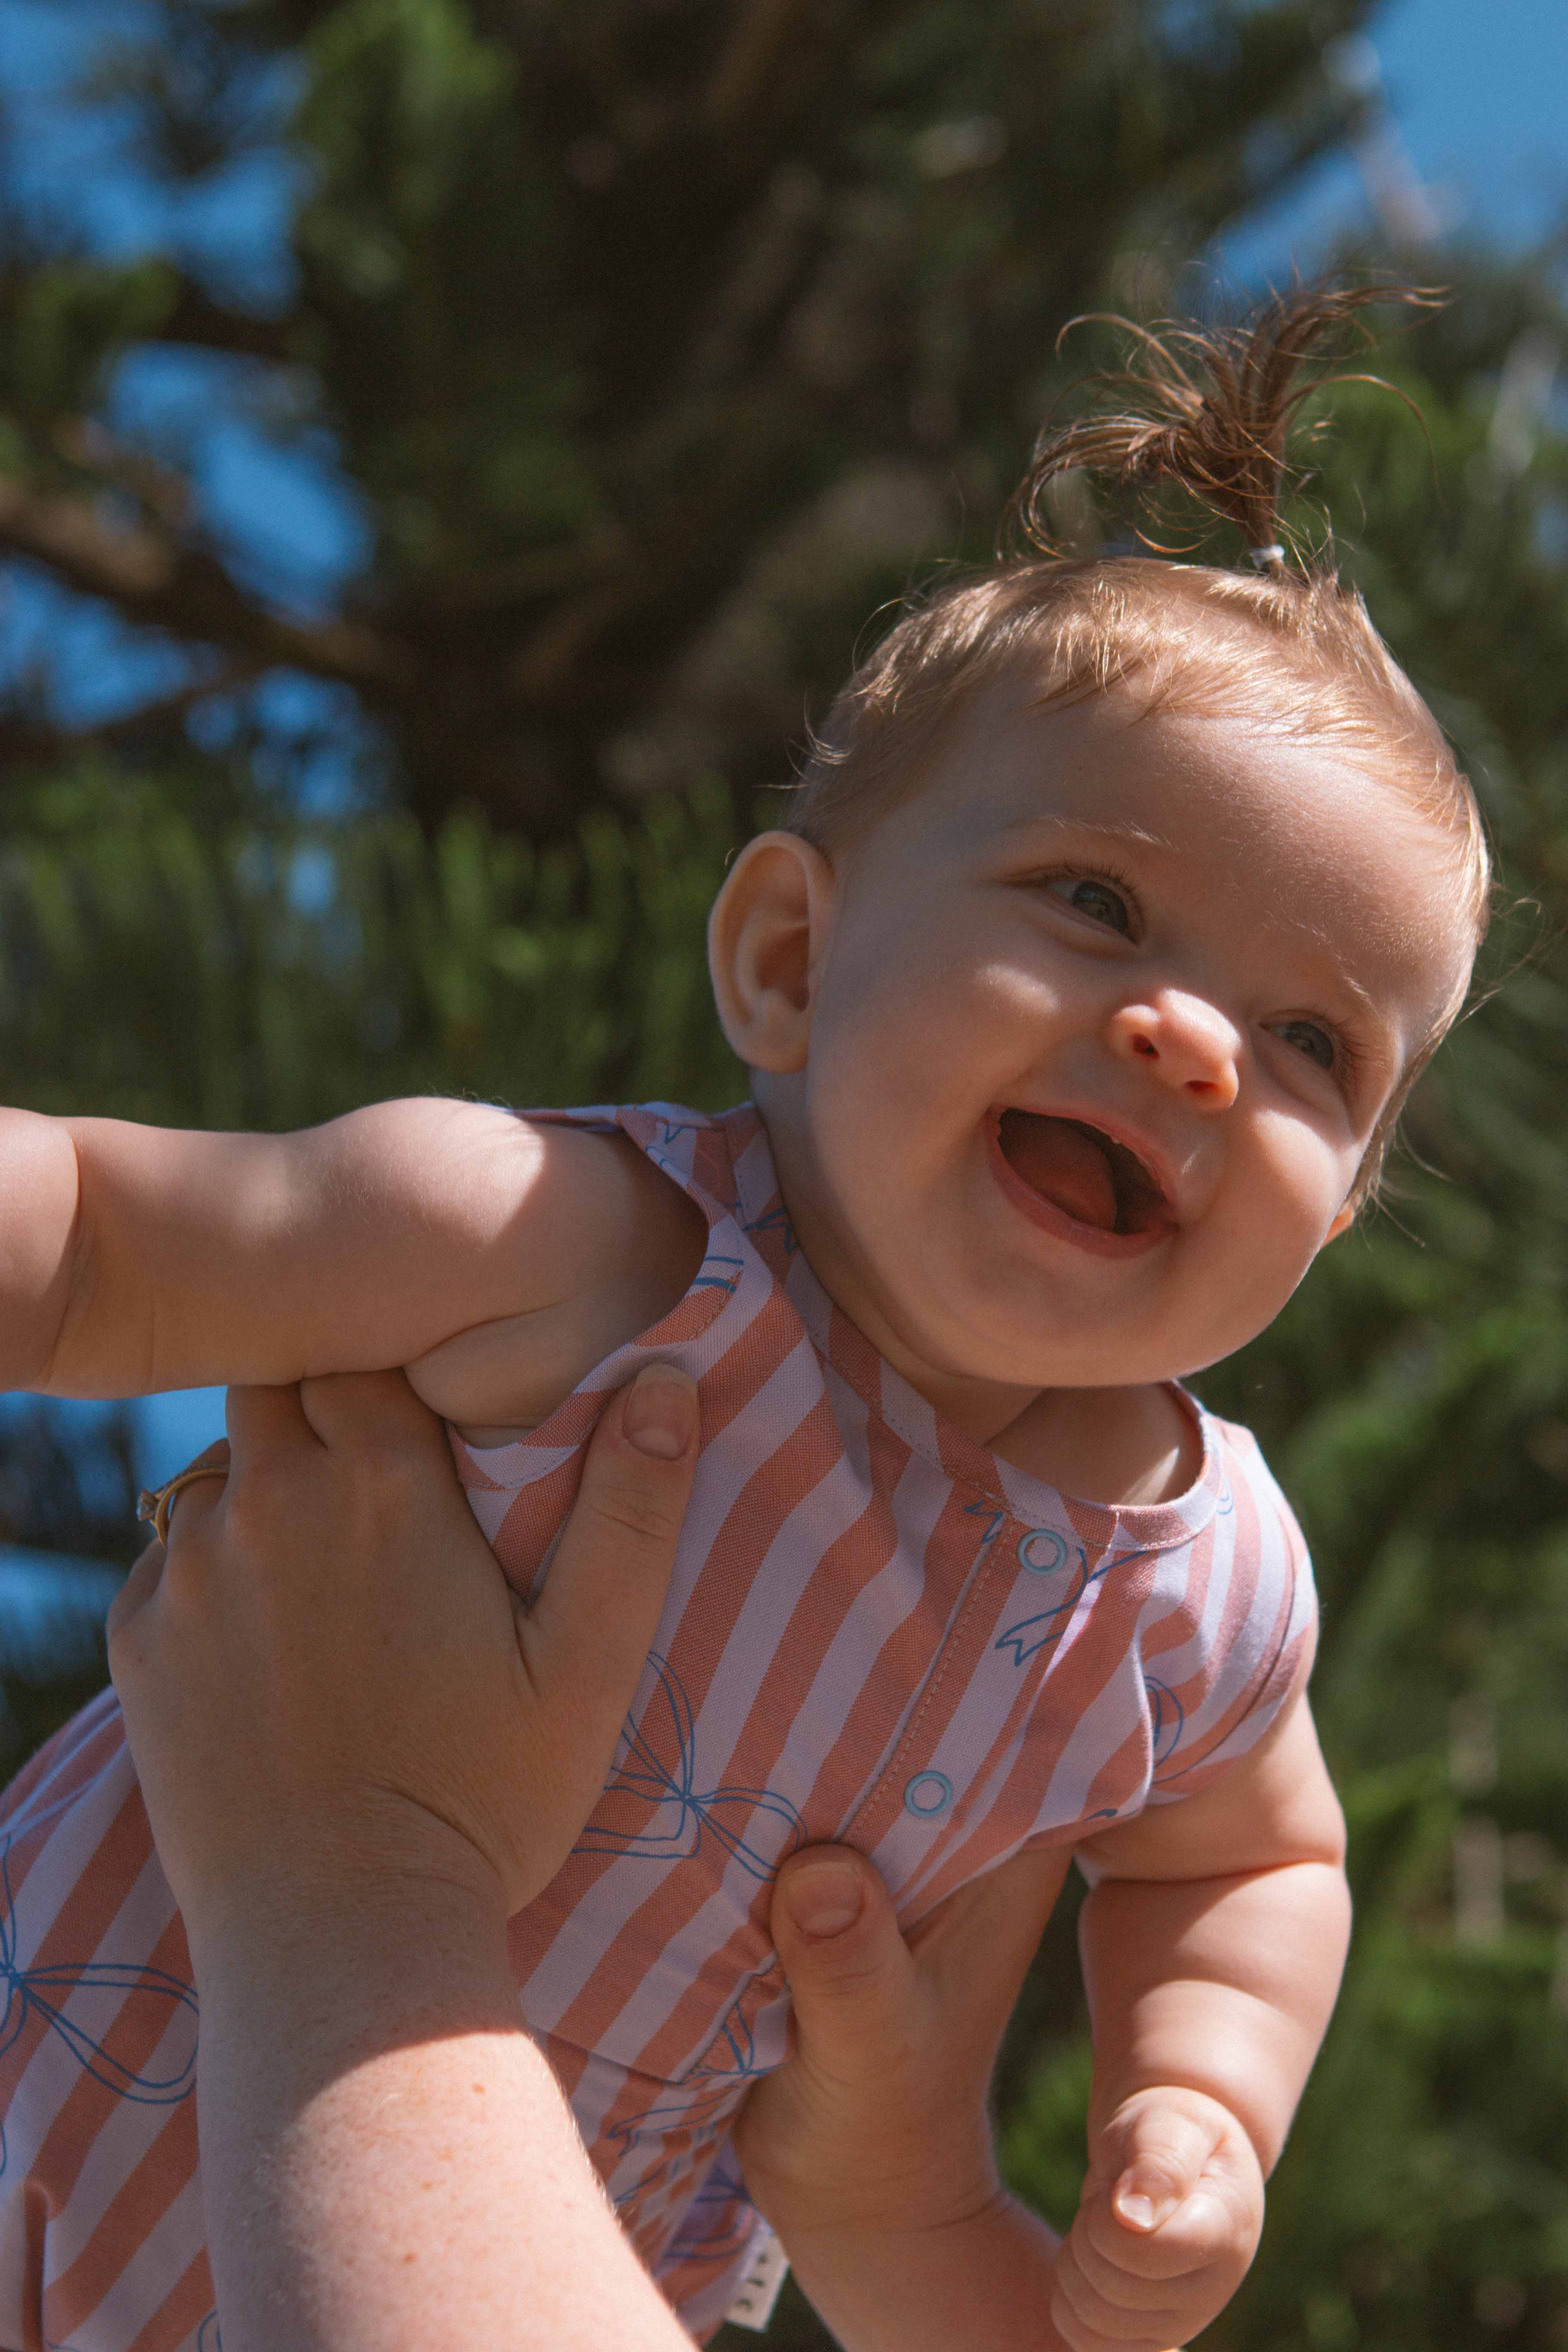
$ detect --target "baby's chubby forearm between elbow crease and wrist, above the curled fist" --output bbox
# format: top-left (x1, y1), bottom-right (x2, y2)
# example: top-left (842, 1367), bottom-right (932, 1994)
top-left (1079, 1860), bottom-right (1349, 2173)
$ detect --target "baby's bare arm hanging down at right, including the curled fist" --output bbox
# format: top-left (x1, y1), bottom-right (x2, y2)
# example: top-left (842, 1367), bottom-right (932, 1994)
top-left (1053, 1689), bottom-right (1349, 2352)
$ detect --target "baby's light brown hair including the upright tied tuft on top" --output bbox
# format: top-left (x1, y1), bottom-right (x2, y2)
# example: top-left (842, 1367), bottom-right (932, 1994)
top-left (783, 287), bottom-right (1491, 1202)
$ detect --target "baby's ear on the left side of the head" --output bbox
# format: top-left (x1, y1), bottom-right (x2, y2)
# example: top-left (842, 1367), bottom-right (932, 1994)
top-left (707, 833), bottom-right (835, 1072)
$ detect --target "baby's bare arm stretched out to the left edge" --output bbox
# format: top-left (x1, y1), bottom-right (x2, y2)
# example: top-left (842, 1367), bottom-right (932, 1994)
top-left (0, 1098), bottom-right (701, 1423)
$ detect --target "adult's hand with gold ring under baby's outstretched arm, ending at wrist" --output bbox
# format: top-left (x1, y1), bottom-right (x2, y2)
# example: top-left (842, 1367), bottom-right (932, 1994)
top-left (108, 1364), bottom-right (696, 1966)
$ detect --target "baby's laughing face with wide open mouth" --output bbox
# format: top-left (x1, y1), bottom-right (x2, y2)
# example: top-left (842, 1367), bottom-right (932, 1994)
top-left (769, 684), bottom-right (1469, 1395)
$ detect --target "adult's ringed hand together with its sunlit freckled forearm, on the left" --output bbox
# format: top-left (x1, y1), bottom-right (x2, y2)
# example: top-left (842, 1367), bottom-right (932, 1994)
top-left (110, 1366), bottom-right (696, 2352)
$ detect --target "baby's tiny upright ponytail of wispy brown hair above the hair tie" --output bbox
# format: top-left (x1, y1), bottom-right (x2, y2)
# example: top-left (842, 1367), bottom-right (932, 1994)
top-left (1008, 285), bottom-right (1441, 579)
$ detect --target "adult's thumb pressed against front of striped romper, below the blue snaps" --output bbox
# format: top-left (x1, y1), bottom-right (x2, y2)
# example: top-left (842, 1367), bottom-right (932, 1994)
top-left (773, 1847), bottom-right (919, 2077)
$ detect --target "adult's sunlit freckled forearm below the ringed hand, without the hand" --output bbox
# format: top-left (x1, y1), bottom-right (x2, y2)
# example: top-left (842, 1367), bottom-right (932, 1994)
top-left (197, 1886), bottom-right (689, 2352)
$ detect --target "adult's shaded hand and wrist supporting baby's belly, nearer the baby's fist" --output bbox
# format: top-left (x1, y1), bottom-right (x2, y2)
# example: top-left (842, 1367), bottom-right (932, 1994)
top-left (736, 1847), bottom-right (1067, 2352)
